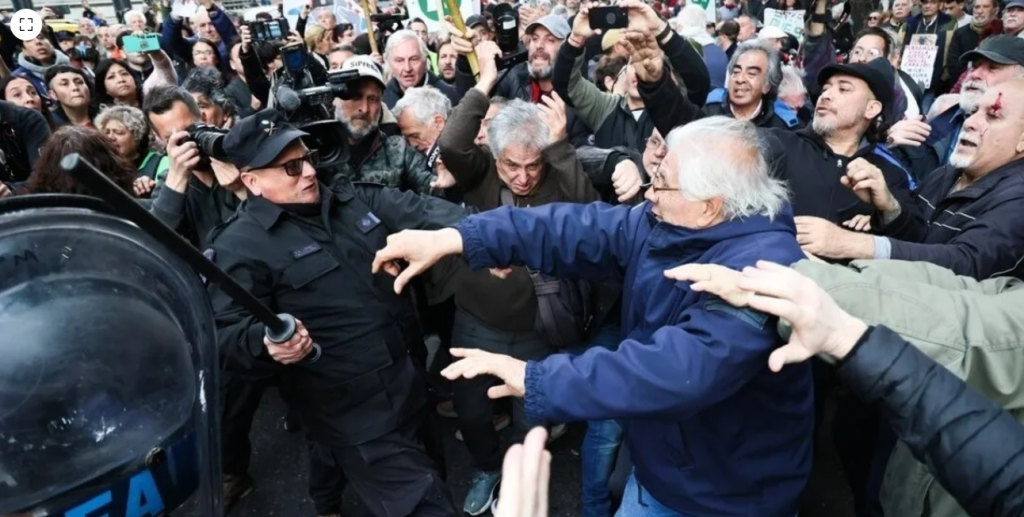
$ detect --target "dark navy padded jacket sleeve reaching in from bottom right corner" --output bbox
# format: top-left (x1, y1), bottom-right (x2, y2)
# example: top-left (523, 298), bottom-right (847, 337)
top-left (839, 327), bottom-right (1024, 511)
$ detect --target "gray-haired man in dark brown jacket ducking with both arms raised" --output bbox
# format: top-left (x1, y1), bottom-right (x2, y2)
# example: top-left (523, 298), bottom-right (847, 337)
top-left (438, 41), bottom-right (598, 515)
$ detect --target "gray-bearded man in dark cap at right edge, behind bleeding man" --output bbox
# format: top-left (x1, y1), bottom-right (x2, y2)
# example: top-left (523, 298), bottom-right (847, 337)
top-left (889, 36), bottom-right (1024, 180)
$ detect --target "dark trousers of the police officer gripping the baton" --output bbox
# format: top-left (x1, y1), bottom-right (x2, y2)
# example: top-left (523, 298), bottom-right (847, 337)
top-left (310, 418), bottom-right (456, 517)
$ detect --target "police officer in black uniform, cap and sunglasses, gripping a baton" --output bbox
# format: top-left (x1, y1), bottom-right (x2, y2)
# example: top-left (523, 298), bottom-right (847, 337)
top-left (206, 111), bottom-right (465, 517)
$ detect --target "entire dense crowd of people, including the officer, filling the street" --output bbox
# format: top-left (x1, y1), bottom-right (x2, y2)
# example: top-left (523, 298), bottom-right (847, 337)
top-left (0, 0), bottom-right (1024, 517)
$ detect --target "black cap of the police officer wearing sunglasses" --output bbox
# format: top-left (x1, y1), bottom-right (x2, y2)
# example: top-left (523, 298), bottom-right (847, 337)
top-left (224, 110), bottom-right (307, 171)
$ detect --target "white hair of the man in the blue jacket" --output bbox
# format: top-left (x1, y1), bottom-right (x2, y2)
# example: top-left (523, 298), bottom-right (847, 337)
top-left (667, 117), bottom-right (787, 220)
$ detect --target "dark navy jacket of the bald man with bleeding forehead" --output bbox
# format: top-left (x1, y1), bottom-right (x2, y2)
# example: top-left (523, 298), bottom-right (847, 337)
top-left (881, 159), bottom-right (1024, 279)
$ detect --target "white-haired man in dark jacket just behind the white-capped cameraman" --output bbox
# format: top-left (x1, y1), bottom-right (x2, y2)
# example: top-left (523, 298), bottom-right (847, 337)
top-left (384, 29), bottom-right (459, 107)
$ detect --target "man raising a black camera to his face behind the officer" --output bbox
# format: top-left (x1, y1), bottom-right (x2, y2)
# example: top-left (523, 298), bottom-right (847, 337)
top-left (142, 86), bottom-right (246, 248)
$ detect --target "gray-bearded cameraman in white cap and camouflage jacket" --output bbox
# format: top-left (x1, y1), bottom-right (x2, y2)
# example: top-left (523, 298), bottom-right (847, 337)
top-left (318, 56), bottom-right (441, 195)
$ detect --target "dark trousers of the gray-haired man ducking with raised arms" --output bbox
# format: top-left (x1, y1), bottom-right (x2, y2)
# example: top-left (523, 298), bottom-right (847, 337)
top-left (452, 310), bottom-right (556, 472)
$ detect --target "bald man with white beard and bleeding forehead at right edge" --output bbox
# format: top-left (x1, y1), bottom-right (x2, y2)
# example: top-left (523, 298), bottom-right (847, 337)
top-left (815, 79), bottom-right (1024, 279)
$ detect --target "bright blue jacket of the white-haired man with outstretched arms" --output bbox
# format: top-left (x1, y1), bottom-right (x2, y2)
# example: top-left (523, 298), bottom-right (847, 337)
top-left (458, 203), bottom-right (814, 517)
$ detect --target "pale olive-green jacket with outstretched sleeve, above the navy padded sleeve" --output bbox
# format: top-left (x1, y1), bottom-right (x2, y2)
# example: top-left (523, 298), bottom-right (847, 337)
top-left (795, 260), bottom-right (1024, 517)
